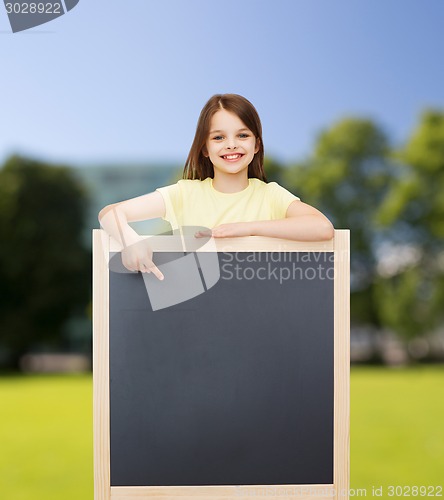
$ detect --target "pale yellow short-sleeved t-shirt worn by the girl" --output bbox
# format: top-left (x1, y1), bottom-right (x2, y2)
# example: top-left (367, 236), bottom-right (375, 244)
top-left (156, 177), bottom-right (299, 229)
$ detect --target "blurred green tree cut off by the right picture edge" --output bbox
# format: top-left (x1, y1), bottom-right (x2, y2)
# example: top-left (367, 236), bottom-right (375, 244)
top-left (374, 110), bottom-right (444, 339)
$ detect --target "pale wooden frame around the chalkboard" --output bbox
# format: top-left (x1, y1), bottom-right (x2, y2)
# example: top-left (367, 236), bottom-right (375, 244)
top-left (93, 229), bottom-right (350, 500)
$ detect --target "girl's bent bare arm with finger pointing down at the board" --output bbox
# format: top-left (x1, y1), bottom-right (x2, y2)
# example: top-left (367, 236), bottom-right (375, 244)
top-left (99, 191), bottom-right (165, 279)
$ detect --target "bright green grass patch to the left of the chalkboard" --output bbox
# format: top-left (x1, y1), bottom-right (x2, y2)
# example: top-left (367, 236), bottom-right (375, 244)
top-left (0, 375), bottom-right (93, 500)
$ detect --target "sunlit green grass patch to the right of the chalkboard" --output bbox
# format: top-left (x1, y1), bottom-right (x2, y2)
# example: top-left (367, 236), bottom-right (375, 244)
top-left (350, 366), bottom-right (444, 498)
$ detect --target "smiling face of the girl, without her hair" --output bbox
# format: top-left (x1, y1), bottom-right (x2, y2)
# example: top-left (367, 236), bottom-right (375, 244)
top-left (203, 109), bottom-right (259, 177)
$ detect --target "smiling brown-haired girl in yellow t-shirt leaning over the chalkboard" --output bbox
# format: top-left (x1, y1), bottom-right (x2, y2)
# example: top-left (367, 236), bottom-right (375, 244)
top-left (99, 94), bottom-right (334, 279)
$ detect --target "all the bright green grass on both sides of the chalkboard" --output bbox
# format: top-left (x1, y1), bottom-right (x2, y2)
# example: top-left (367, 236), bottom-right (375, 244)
top-left (0, 366), bottom-right (444, 500)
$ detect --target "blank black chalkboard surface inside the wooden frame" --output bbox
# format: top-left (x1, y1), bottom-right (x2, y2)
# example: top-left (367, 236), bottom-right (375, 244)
top-left (109, 252), bottom-right (334, 486)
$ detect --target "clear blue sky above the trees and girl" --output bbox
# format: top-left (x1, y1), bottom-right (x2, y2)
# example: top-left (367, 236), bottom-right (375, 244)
top-left (0, 0), bottom-right (444, 164)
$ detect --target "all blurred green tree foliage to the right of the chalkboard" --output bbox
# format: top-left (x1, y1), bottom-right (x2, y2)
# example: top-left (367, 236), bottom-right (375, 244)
top-left (287, 110), bottom-right (444, 339)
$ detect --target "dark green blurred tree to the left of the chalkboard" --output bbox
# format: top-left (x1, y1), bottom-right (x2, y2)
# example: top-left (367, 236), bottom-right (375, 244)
top-left (0, 156), bottom-right (90, 370)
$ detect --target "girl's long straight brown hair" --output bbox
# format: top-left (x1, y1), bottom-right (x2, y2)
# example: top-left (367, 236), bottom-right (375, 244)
top-left (183, 94), bottom-right (267, 182)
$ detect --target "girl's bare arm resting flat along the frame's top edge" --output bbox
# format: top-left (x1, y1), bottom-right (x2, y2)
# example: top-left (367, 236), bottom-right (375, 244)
top-left (196, 200), bottom-right (334, 241)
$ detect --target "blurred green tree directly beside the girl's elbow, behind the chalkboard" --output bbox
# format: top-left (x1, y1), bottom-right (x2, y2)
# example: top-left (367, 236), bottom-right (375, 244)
top-left (287, 118), bottom-right (394, 326)
